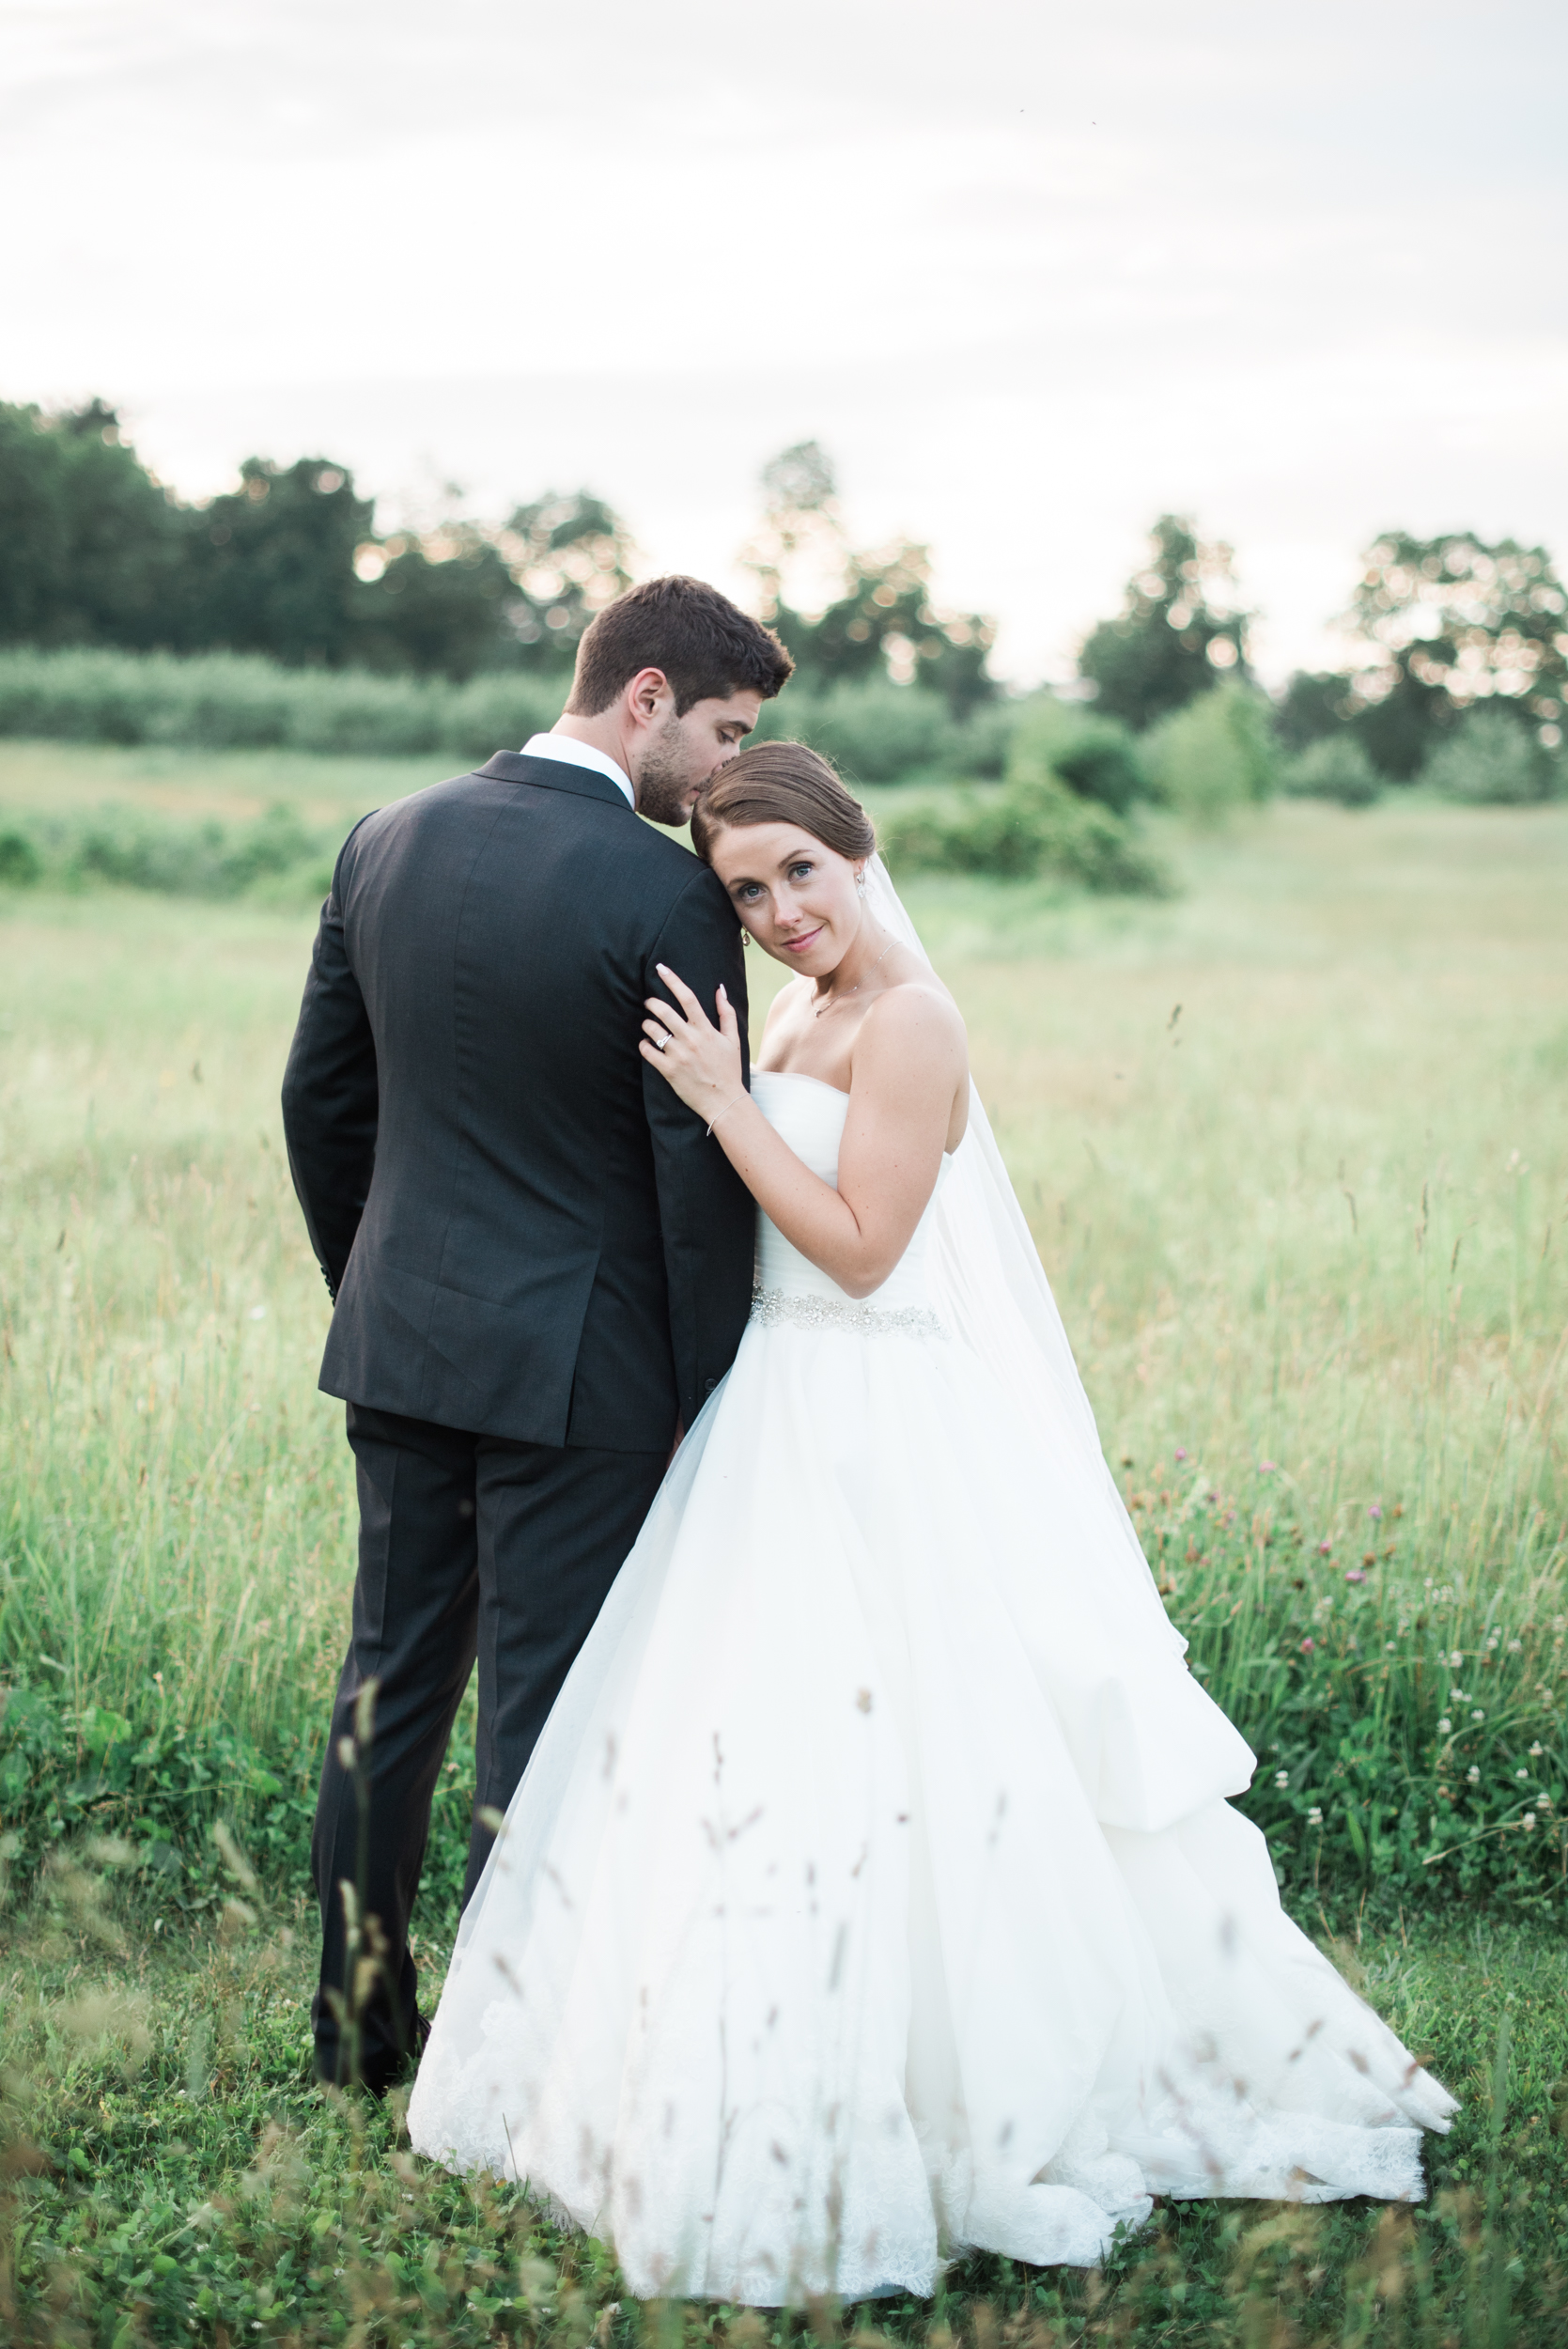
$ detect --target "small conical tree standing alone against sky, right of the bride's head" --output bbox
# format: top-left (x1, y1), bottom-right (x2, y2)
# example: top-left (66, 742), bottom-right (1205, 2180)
top-left (1078, 515), bottom-right (1249, 733)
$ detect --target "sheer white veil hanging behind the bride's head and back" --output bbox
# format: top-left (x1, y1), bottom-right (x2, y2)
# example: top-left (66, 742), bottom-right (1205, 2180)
top-left (866, 858), bottom-right (1188, 1652)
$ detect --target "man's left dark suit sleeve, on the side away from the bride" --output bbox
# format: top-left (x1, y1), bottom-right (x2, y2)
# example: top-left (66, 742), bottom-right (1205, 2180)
top-left (284, 834), bottom-right (380, 1299)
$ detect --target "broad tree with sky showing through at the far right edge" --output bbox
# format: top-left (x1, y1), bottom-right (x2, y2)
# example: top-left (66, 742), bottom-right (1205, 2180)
top-left (1345, 531), bottom-right (1568, 780)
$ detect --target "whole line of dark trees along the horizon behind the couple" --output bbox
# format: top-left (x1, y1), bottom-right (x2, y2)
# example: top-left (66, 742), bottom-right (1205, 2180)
top-left (0, 399), bottom-right (1568, 780)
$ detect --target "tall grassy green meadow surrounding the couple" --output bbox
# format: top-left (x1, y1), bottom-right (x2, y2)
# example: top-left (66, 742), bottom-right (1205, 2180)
top-left (0, 742), bottom-right (1568, 2349)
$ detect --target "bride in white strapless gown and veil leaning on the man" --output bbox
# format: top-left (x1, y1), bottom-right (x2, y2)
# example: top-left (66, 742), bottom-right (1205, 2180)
top-left (409, 742), bottom-right (1453, 2307)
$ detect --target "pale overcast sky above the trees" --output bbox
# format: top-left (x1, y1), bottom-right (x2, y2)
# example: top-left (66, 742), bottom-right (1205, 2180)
top-left (0, 0), bottom-right (1568, 679)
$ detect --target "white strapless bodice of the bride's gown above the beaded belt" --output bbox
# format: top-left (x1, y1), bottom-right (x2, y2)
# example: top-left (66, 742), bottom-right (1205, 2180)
top-left (752, 1069), bottom-right (948, 1334)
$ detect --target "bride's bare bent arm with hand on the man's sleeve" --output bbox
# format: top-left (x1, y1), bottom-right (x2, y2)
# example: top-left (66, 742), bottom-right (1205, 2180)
top-left (641, 971), bottom-right (967, 1297)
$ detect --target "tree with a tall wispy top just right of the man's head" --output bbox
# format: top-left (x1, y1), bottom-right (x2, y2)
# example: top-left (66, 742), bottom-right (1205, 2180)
top-left (744, 442), bottom-right (995, 719)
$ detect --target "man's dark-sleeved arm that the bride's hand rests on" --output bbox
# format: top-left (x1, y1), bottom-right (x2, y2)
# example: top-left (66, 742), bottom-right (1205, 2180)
top-left (644, 864), bottom-right (756, 1428)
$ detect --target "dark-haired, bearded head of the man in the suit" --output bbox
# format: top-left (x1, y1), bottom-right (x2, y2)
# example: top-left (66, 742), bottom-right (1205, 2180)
top-left (566, 578), bottom-right (793, 825)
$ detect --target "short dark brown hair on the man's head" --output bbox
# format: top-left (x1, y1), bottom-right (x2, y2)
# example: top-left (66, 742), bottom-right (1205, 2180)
top-left (566, 573), bottom-right (796, 719)
